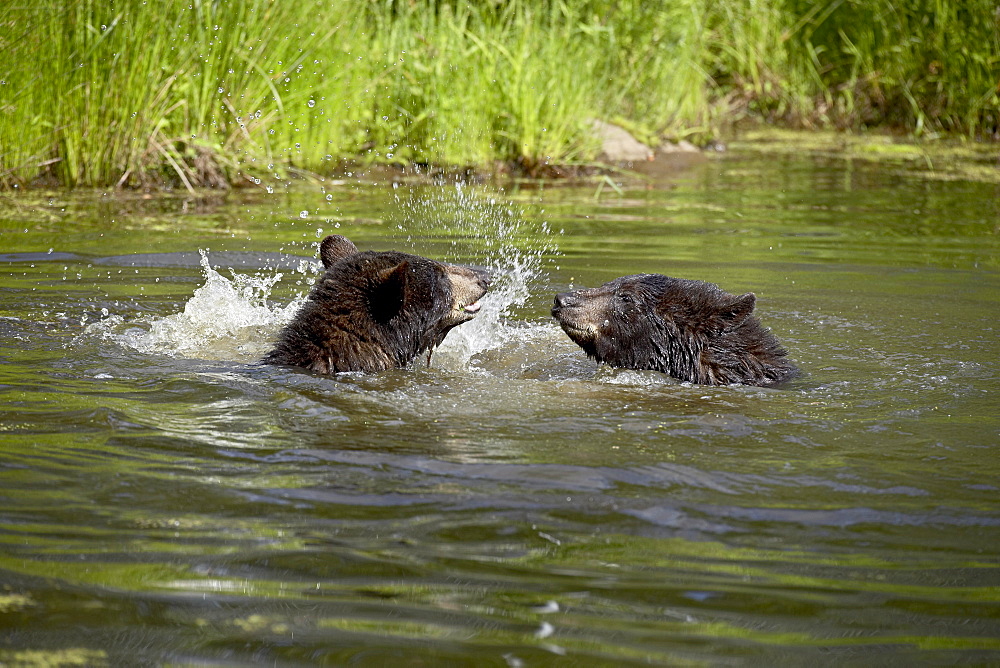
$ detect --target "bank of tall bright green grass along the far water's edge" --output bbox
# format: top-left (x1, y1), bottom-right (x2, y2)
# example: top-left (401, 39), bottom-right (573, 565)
top-left (0, 0), bottom-right (1000, 187)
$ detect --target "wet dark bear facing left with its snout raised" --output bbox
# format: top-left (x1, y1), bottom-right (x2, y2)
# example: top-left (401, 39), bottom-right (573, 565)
top-left (552, 274), bottom-right (798, 386)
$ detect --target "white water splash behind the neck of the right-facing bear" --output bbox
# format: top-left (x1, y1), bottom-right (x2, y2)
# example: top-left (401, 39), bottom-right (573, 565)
top-left (84, 250), bottom-right (308, 361)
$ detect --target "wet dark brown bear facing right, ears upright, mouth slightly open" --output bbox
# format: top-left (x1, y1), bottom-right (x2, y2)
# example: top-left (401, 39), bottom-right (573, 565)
top-left (262, 234), bottom-right (490, 374)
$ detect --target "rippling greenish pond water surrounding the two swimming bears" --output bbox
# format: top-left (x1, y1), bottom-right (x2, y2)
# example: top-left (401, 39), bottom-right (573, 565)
top-left (0, 154), bottom-right (1000, 666)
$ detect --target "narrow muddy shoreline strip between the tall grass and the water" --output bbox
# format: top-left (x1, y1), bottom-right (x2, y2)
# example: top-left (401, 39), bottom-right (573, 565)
top-left (0, 126), bottom-right (1000, 194)
